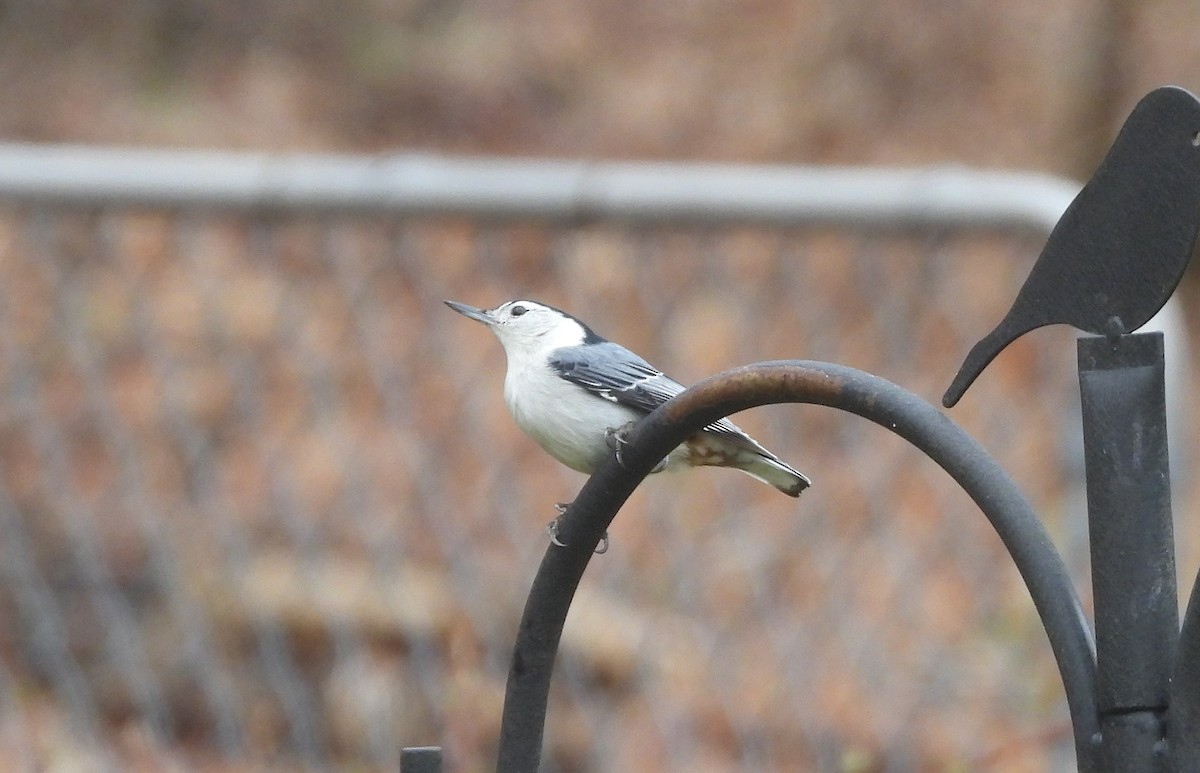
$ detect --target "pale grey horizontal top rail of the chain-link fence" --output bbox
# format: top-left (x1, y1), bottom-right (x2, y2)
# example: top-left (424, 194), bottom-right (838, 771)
top-left (0, 143), bottom-right (1080, 232)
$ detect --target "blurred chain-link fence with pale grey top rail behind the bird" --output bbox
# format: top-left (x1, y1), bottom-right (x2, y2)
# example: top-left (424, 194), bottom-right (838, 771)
top-left (0, 148), bottom-right (1195, 772)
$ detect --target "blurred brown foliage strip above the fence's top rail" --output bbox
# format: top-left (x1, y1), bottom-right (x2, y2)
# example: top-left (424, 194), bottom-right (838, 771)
top-left (0, 0), bottom-right (1200, 176)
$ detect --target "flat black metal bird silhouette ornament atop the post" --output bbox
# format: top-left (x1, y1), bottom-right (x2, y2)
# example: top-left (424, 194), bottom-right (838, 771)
top-left (942, 86), bottom-right (1200, 408)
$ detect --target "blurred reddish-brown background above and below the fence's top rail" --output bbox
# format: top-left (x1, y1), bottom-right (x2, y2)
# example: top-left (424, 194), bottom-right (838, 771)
top-left (0, 0), bottom-right (1200, 772)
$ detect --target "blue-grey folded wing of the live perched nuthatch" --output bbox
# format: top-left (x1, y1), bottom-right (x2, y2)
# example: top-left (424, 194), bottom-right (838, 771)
top-left (550, 341), bottom-right (757, 445)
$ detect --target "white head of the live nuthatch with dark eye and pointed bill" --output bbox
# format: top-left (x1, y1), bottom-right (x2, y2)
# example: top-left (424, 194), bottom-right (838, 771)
top-left (445, 300), bottom-right (602, 355)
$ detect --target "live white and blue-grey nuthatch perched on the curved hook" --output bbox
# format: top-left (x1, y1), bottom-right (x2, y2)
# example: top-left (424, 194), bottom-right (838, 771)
top-left (445, 300), bottom-right (810, 497)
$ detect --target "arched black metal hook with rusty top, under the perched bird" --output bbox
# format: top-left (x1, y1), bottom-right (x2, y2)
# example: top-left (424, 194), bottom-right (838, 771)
top-left (497, 360), bottom-right (1099, 773)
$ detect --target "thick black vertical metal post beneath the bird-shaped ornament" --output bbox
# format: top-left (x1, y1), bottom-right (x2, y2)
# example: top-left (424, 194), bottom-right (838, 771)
top-left (1079, 332), bottom-right (1178, 773)
